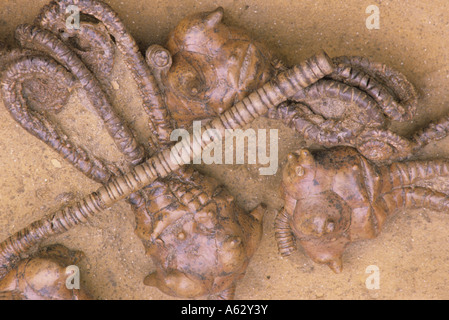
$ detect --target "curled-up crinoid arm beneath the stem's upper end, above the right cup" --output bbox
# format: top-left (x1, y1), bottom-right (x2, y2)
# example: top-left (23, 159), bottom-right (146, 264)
top-left (269, 80), bottom-right (385, 146)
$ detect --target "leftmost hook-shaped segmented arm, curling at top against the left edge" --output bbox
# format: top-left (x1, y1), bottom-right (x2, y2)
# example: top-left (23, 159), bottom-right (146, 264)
top-left (0, 56), bottom-right (111, 183)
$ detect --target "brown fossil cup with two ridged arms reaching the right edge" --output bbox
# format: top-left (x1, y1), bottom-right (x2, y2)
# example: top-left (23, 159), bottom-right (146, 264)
top-left (275, 147), bottom-right (449, 272)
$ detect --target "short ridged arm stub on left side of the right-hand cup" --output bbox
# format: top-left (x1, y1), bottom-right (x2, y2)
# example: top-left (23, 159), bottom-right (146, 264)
top-left (274, 209), bottom-right (296, 257)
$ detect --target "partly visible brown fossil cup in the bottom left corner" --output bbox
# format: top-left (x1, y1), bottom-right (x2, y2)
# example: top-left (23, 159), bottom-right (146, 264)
top-left (0, 245), bottom-right (90, 300)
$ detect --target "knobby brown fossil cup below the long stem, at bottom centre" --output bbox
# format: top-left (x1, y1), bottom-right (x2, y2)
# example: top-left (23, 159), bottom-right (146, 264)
top-left (134, 169), bottom-right (265, 299)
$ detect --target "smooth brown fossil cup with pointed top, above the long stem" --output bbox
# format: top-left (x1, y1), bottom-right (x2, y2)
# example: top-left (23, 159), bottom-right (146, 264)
top-left (147, 8), bottom-right (274, 127)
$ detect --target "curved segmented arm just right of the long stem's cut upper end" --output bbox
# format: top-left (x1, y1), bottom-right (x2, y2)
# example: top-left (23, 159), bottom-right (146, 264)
top-left (329, 56), bottom-right (418, 121)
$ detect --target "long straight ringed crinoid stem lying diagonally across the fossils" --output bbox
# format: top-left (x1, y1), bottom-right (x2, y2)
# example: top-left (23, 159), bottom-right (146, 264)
top-left (0, 52), bottom-right (333, 276)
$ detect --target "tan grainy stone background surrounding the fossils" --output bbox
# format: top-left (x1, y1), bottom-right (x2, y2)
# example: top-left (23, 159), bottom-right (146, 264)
top-left (0, 0), bottom-right (449, 299)
